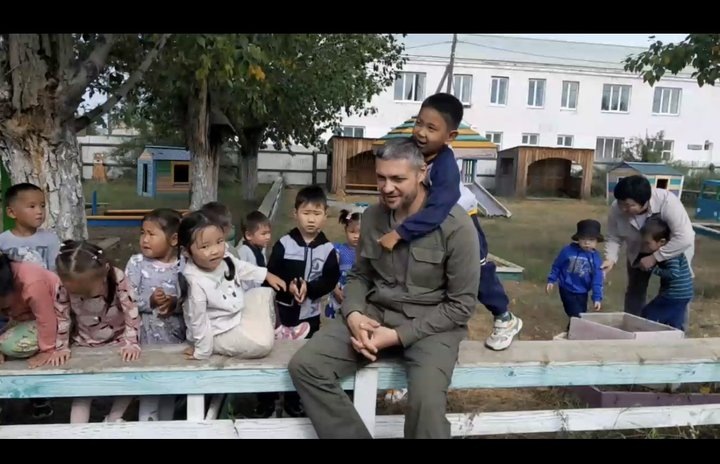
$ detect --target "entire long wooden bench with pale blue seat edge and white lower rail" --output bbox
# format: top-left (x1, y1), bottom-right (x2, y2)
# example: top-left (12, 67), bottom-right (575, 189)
top-left (0, 338), bottom-right (720, 438)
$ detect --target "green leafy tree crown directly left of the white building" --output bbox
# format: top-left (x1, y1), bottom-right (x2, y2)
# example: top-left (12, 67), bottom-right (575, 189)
top-left (108, 34), bottom-right (404, 152)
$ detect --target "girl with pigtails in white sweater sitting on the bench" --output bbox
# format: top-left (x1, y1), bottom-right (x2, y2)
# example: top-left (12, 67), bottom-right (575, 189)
top-left (178, 212), bottom-right (286, 359)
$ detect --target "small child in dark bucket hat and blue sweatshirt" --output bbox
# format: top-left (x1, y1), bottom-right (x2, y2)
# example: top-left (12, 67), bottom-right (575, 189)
top-left (546, 219), bottom-right (604, 326)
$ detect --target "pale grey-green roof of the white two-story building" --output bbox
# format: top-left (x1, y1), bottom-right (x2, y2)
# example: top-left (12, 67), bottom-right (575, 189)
top-left (404, 34), bottom-right (690, 77)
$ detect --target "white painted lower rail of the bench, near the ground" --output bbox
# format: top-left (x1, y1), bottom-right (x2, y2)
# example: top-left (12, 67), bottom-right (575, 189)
top-left (5, 404), bottom-right (720, 439)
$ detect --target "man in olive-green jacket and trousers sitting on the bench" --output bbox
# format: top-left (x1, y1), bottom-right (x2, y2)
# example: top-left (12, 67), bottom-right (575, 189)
top-left (288, 139), bottom-right (480, 438)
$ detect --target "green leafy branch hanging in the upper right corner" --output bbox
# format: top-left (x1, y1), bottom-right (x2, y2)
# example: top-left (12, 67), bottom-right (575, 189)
top-left (624, 34), bottom-right (720, 87)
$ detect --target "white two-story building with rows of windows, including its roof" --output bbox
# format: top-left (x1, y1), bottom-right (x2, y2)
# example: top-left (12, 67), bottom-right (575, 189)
top-left (342, 34), bottom-right (720, 174)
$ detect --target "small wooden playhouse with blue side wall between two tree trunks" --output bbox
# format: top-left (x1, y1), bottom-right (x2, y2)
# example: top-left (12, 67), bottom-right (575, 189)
top-left (137, 145), bottom-right (191, 198)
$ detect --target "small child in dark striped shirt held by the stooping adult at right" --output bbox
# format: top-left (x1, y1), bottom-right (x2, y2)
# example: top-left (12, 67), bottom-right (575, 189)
top-left (638, 216), bottom-right (693, 331)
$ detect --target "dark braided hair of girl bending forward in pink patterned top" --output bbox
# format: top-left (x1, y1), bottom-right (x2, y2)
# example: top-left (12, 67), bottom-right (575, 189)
top-left (55, 240), bottom-right (117, 306)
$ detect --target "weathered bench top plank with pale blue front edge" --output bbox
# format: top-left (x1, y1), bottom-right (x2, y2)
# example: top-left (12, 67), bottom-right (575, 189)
top-left (0, 338), bottom-right (720, 398)
